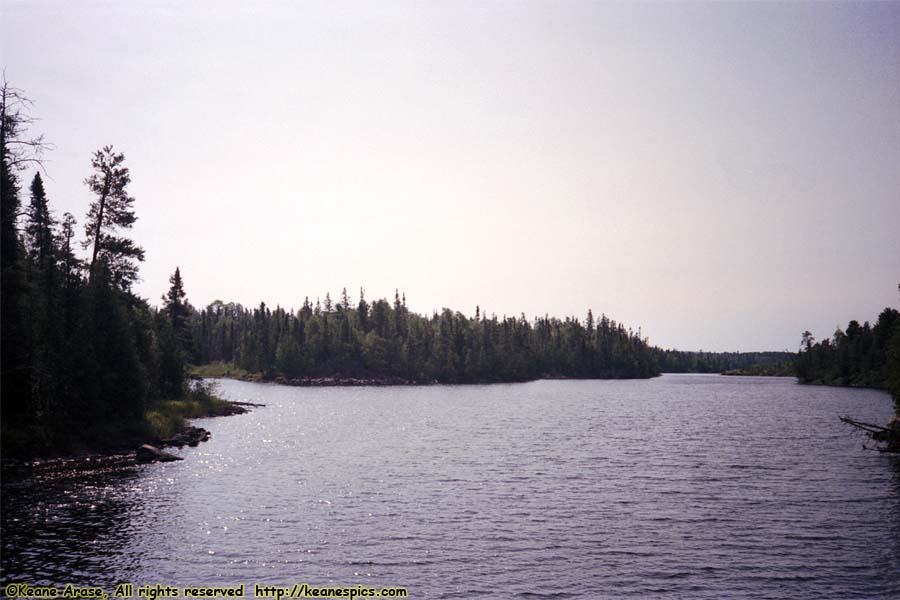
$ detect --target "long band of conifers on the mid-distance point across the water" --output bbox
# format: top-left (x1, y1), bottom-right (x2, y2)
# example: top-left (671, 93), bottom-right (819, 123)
top-left (190, 289), bottom-right (659, 383)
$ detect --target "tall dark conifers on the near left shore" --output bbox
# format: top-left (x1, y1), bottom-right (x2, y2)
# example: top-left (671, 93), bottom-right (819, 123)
top-left (0, 84), bottom-right (185, 455)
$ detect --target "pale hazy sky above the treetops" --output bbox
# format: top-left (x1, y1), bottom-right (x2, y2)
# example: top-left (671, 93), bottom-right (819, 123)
top-left (0, 0), bottom-right (900, 351)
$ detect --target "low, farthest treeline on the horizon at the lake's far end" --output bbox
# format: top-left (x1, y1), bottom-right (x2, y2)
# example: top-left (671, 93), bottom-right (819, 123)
top-left (654, 348), bottom-right (797, 375)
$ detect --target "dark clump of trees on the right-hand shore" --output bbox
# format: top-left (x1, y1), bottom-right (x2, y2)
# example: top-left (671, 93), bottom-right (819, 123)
top-left (797, 298), bottom-right (900, 414)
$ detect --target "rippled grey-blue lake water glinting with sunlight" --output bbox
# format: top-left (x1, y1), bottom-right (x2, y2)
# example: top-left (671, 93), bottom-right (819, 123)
top-left (2, 375), bottom-right (900, 599)
